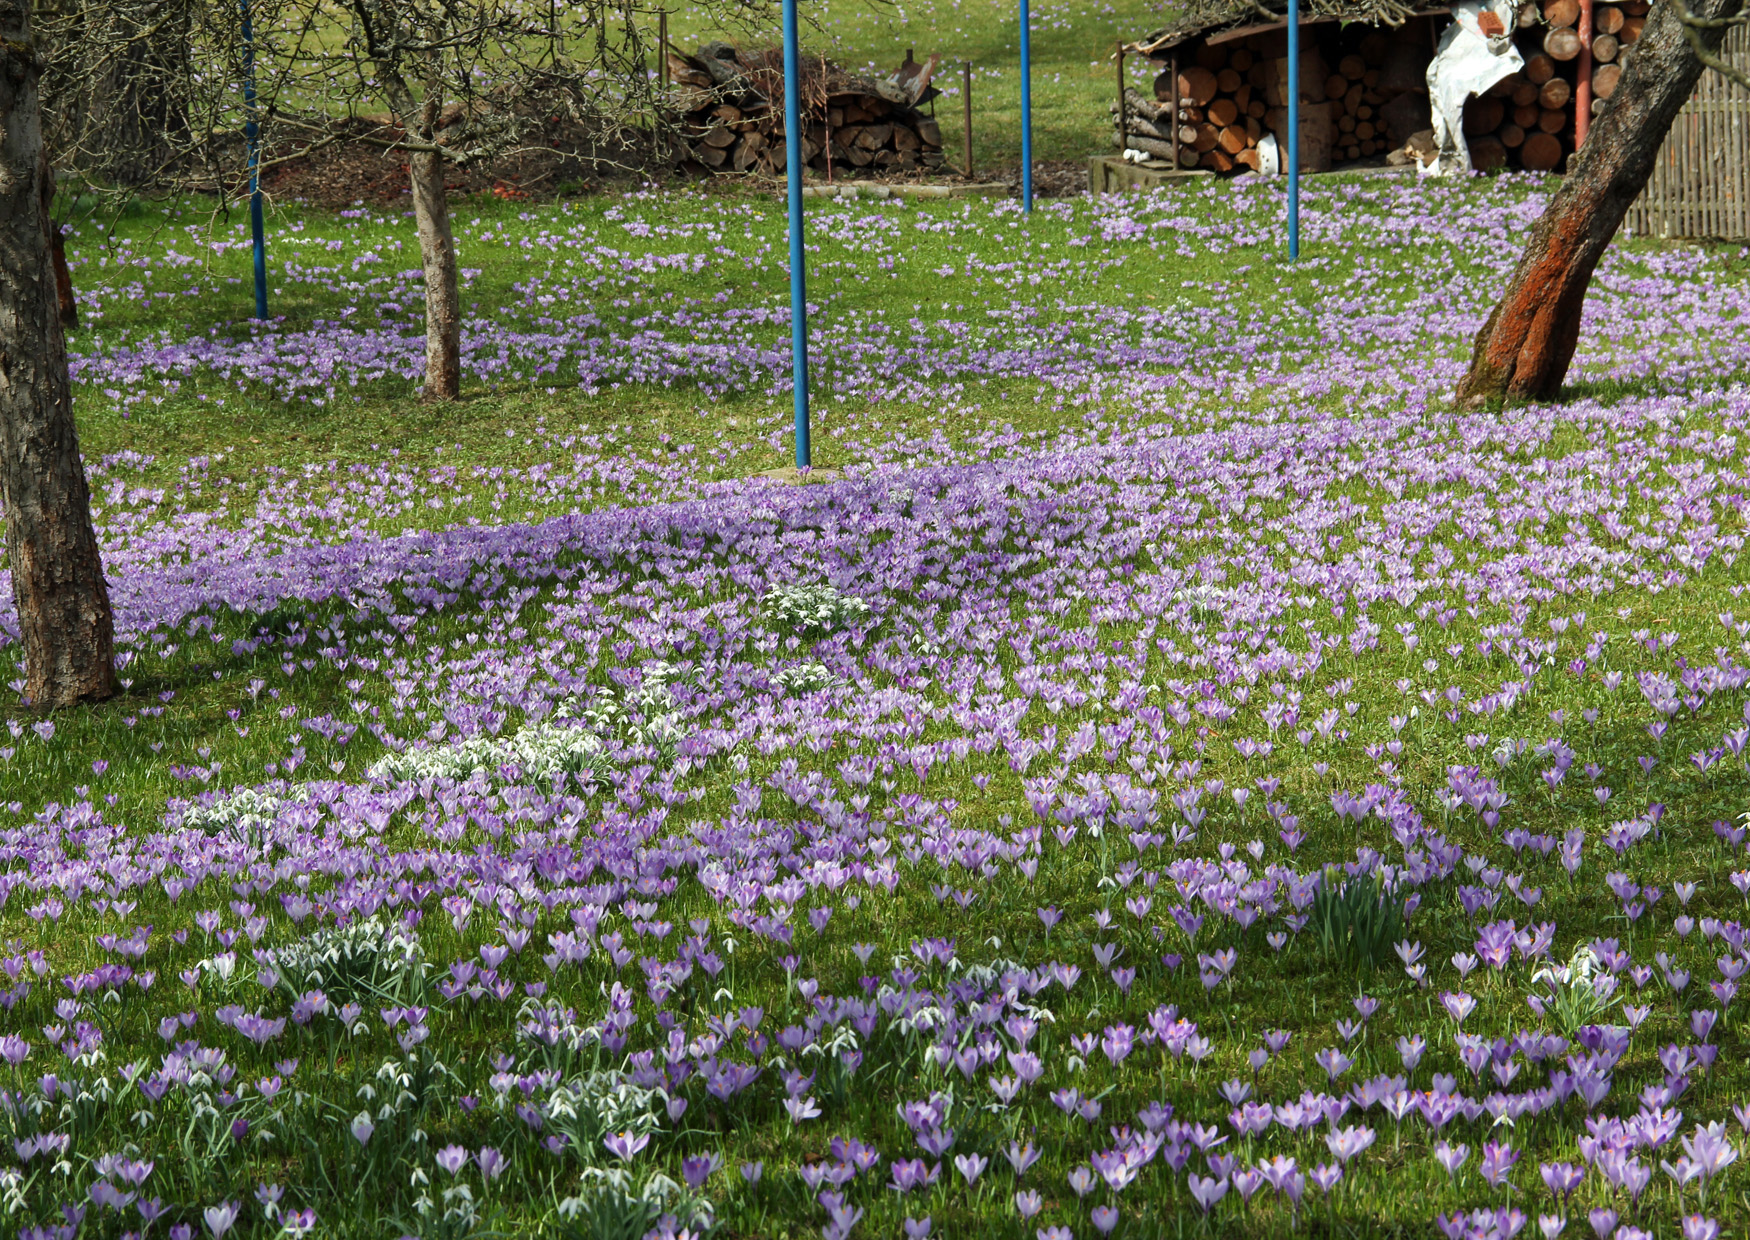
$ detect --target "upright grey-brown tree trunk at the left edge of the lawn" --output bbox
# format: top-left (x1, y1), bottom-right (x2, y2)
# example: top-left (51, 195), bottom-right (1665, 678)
top-left (0, 0), bottom-right (116, 708)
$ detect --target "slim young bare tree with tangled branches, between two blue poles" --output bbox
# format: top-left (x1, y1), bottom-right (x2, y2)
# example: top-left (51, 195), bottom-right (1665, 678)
top-left (241, 0), bottom-right (717, 401)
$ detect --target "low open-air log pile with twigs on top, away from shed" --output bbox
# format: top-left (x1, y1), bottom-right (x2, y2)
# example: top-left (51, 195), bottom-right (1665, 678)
top-left (669, 42), bottom-right (942, 177)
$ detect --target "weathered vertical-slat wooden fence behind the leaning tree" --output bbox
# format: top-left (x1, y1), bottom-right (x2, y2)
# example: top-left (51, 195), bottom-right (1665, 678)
top-left (1624, 26), bottom-right (1750, 241)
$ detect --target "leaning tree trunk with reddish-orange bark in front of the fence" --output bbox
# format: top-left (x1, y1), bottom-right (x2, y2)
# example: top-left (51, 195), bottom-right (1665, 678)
top-left (1458, 0), bottom-right (1745, 406)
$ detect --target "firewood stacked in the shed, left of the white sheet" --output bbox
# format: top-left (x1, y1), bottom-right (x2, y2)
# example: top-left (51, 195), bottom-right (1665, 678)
top-left (1110, 30), bottom-right (1428, 171)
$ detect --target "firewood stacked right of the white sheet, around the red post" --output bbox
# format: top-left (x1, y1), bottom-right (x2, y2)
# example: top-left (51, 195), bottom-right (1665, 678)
top-left (1465, 0), bottom-right (1649, 171)
